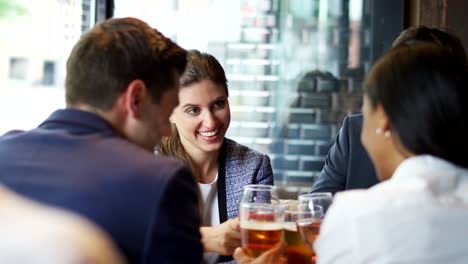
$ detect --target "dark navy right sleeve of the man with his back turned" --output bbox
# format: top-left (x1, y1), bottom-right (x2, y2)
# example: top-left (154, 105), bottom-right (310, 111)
top-left (147, 167), bottom-right (203, 263)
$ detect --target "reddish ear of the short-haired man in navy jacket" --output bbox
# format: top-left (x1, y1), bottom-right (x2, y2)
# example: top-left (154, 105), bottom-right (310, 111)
top-left (124, 80), bottom-right (147, 118)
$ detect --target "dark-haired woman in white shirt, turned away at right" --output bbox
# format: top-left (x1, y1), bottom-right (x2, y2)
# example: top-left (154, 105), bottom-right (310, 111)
top-left (315, 43), bottom-right (468, 263)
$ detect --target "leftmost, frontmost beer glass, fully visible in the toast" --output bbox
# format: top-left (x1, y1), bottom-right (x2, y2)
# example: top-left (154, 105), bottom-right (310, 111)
top-left (239, 184), bottom-right (284, 257)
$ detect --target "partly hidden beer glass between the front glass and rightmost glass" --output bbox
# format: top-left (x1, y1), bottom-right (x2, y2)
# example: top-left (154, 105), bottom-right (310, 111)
top-left (283, 202), bottom-right (313, 264)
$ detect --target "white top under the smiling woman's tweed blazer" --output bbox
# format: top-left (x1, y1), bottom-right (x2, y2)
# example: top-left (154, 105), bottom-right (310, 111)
top-left (198, 174), bottom-right (220, 264)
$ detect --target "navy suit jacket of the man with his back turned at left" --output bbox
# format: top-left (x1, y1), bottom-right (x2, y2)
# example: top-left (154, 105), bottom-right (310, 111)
top-left (0, 109), bottom-right (203, 264)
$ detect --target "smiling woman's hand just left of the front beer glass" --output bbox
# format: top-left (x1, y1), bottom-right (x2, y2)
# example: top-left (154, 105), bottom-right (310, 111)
top-left (200, 218), bottom-right (241, 256)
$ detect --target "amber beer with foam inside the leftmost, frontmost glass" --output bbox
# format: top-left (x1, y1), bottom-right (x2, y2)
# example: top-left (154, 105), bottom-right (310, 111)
top-left (241, 220), bottom-right (282, 257)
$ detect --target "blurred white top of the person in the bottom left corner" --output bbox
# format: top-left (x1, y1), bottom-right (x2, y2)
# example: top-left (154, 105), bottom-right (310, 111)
top-left (0, 186), bottom-right (124, 264)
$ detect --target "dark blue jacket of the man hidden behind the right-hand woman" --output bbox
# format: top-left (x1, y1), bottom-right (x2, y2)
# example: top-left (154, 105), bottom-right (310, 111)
top-left (312, 114), bottom-right (379, 193)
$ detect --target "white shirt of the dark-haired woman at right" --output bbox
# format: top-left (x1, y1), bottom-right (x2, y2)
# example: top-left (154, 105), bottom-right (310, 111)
top-left (315, 155), bottom-right (468, 264)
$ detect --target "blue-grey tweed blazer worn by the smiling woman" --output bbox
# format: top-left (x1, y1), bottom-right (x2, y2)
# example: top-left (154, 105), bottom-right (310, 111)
top-left (217, 138), bottom-right (273, 262)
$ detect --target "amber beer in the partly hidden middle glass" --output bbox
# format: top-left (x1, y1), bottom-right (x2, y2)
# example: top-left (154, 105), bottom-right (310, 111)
top-left (283, 222), bottom-right (313, 264)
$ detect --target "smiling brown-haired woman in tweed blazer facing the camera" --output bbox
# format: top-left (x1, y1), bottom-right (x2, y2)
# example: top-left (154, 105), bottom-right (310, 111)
top-left (158, 50), bottom-right (273, 263)
